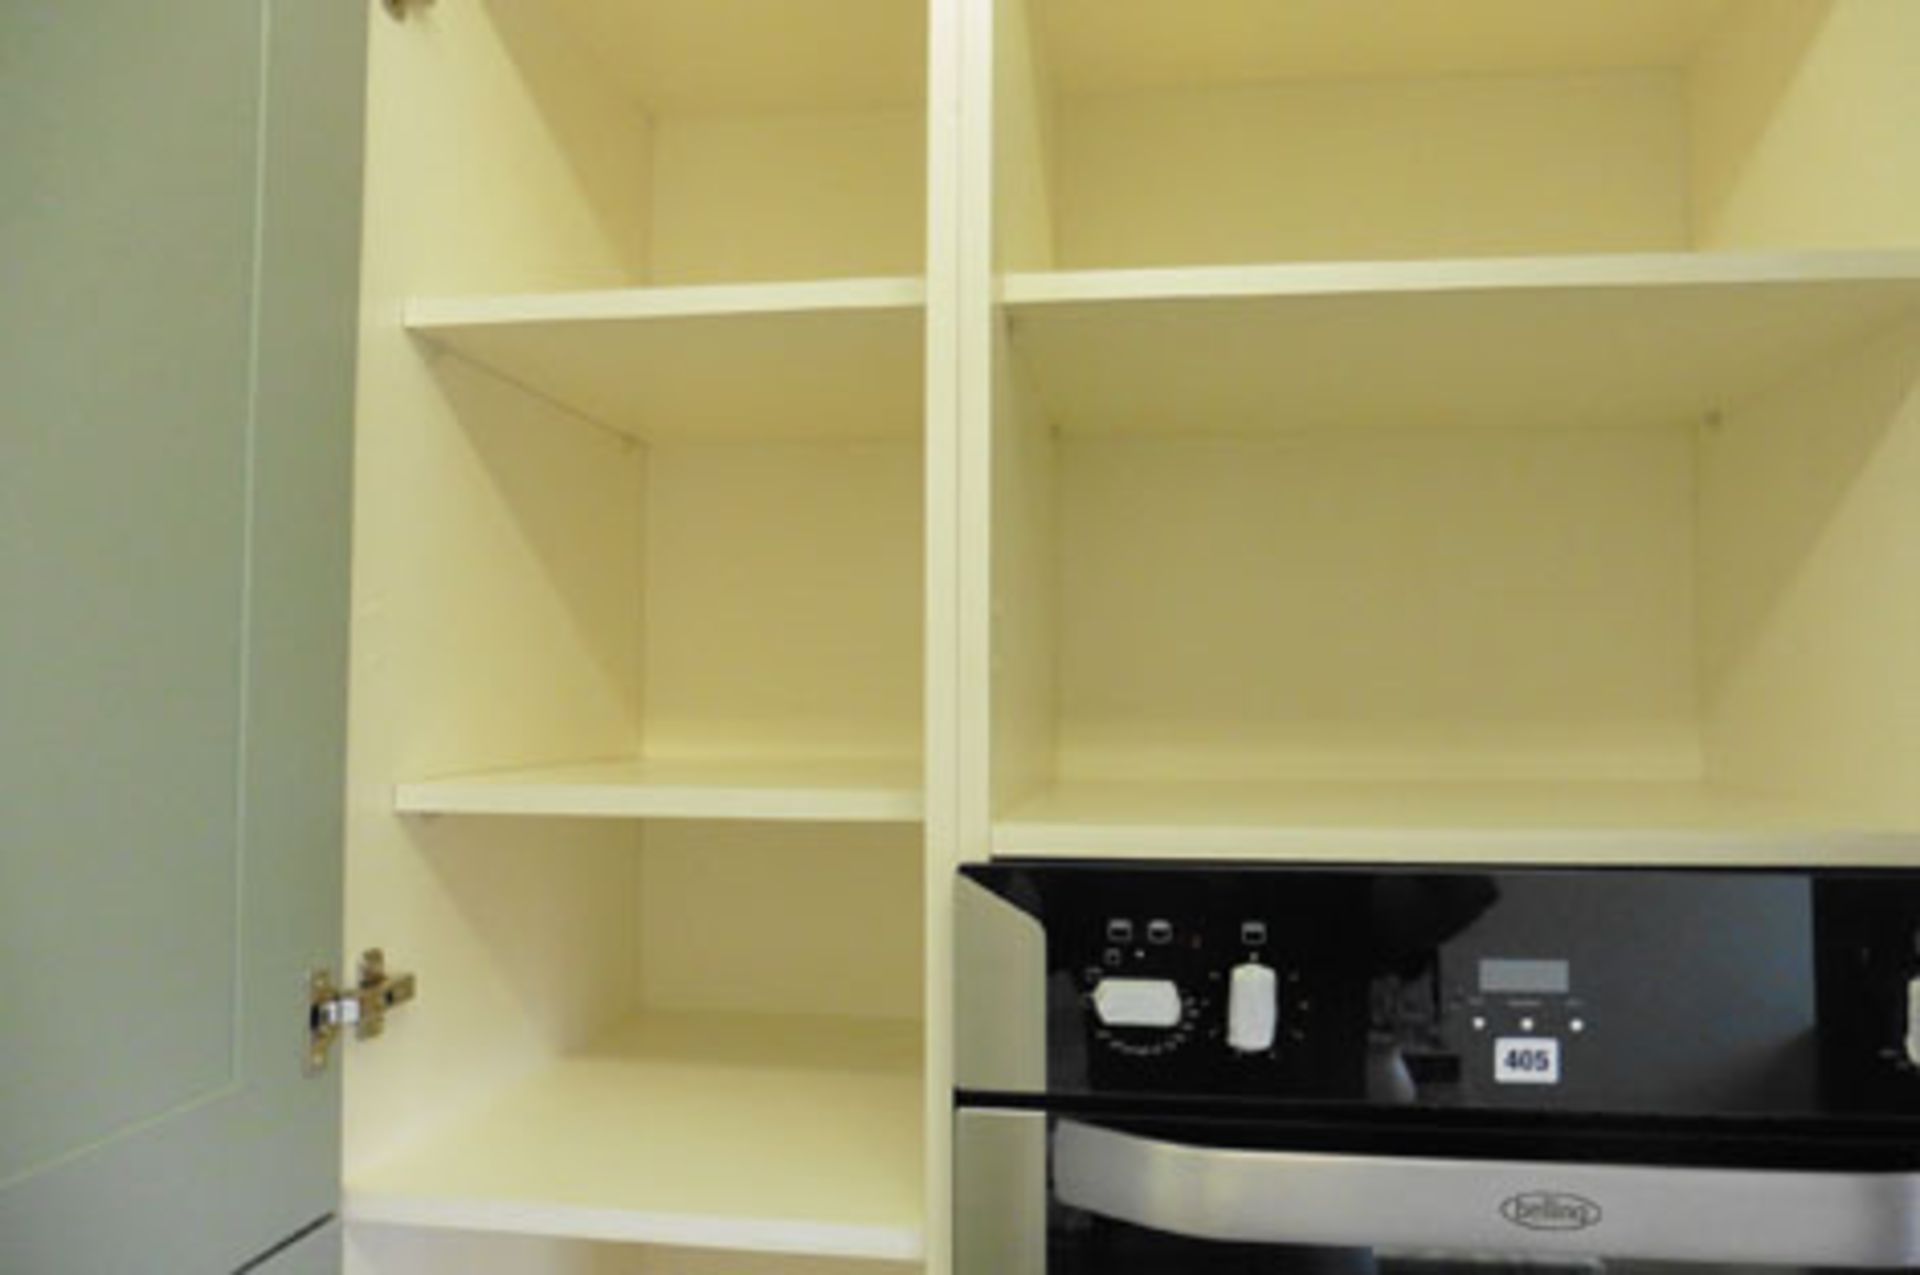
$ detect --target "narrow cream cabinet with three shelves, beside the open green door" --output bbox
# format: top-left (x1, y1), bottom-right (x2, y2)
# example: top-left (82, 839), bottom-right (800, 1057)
top-left (344, 0), bottom-right (950, 1273)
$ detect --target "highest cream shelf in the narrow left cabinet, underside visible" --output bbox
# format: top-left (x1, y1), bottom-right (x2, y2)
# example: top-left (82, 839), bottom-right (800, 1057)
top-left (405, 278), bottom-right (925, 440)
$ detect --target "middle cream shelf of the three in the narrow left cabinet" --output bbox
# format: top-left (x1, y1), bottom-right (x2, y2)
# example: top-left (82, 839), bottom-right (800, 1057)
top-left (394, 760), bottom-right (924, 824)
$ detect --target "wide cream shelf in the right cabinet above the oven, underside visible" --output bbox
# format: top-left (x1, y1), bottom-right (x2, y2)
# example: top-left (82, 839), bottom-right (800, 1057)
top-left (1000, 252), bottom-right (1920, 434)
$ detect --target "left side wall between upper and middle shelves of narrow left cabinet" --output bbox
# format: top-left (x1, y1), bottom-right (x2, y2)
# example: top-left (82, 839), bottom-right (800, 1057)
top-left (361, 362), bottom-right (645, 780)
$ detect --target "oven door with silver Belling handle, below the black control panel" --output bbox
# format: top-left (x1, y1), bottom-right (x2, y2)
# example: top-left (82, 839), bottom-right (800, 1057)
top-left (954, 1110), bottom-right (1920, 1275)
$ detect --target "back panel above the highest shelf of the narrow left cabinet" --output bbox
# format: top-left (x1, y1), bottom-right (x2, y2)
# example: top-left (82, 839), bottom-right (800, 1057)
top-left (649, 109), bottom-right (925, 284)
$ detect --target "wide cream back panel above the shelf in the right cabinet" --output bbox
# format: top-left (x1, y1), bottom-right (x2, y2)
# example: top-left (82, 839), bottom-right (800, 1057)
top-left (1054, 71), bottom-right (1688, 267)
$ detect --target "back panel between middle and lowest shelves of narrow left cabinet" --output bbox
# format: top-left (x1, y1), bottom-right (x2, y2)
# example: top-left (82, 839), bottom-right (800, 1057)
top-left (637, 822), bottom-right (922, 1018)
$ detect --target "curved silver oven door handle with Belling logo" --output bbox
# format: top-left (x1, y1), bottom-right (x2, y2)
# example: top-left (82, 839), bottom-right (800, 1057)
top-left (1052, 1119), bottom-right (1920, 1269)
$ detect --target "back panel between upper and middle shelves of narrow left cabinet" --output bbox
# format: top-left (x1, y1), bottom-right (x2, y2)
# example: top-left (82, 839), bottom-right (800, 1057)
top-left (641, 442), bottom-right (924, 758)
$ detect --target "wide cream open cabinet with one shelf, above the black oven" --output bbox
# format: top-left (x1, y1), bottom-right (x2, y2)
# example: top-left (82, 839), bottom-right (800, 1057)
top-left (960, 0), bottom-right (1920, 862)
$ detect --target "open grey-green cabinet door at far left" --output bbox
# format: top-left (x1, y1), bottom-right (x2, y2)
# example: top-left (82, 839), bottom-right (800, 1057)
top-left (0, 0), bottom-right (367, 1275)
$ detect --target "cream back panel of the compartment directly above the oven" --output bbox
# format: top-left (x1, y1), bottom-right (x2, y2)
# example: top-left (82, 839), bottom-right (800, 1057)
top-left (1058, 428), bottom-right (1699, 780)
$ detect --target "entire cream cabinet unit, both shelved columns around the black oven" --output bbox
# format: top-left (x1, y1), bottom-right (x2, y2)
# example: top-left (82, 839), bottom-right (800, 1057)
top-left (15, 0), bottom-right (1920, 1275)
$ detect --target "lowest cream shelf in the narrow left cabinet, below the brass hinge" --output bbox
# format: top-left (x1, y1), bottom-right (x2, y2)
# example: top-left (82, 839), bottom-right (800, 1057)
top-left (346, 1014), bottom-right (924, 1262)
